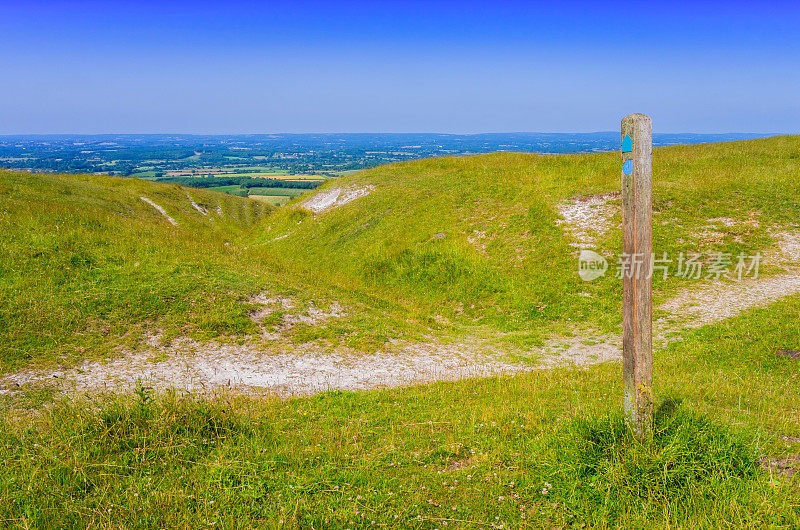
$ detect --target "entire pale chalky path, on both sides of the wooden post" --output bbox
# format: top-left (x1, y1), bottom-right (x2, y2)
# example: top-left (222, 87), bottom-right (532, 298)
top-left (0, 262), bottom-right (800, 396)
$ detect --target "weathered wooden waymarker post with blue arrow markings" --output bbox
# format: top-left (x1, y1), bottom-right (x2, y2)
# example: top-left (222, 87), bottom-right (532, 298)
top-left (622, 114), bottom-right (653, 441)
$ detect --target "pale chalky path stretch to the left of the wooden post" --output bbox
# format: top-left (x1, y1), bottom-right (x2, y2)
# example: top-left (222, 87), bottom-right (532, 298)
top-left (0, 337), bottom-right (619, 396)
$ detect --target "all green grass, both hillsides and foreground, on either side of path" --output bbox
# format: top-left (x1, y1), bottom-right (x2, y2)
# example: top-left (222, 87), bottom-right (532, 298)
top-left (0, 137), bottom-right (800, 528)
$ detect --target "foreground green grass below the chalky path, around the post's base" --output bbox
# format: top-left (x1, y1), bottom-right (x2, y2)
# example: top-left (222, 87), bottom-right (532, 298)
top-left (0, 297), bottom-right (800, 528)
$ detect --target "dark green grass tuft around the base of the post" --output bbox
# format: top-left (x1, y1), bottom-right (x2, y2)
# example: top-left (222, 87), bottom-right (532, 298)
top-left (548, 399), bottom-right (760, 526)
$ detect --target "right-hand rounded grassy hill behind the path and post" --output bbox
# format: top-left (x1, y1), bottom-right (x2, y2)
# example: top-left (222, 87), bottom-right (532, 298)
top-left (260, 137), bottom-right (800, 343)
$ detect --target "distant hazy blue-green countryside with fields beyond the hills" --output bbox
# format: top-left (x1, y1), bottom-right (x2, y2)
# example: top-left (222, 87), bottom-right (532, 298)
top-left (0, 132), bottom-right (766, 206)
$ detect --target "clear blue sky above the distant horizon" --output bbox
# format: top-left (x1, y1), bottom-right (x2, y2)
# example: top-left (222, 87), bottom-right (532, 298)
top-left (0, 0), bottom-right (800, 134)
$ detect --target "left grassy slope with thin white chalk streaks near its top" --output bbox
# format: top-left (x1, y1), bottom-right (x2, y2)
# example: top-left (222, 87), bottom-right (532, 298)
top-left (0, 172), bottom-right (269, 369)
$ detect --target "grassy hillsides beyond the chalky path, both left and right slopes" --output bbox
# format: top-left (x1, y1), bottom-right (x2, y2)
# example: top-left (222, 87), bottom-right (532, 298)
top-left (0, 137), bottom-right (800, 369)
